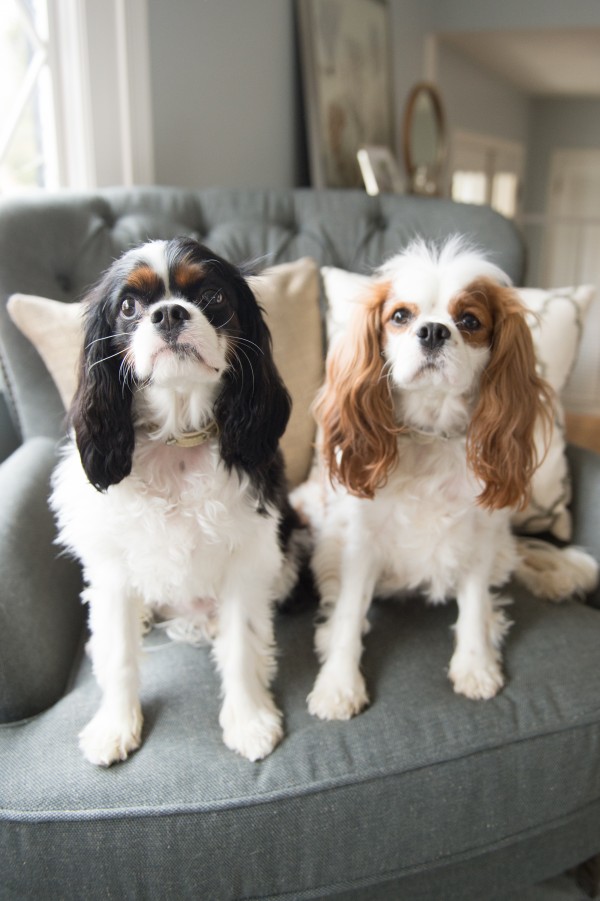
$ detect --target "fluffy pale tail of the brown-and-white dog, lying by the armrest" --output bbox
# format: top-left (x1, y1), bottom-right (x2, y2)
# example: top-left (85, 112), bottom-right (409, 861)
top-left (515, 538), bottom-right (598, 601)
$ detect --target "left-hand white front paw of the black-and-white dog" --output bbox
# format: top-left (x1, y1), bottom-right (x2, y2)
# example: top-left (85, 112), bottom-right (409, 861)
top-left (79, 707), bottom-right (143, 766)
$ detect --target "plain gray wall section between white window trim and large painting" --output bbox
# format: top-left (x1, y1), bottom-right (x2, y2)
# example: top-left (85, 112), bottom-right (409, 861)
top-left (148, 0), bottom-right (303, 187)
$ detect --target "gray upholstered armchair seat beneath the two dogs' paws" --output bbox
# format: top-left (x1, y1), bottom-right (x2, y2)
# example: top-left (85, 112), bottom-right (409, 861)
top-left (0, 592), bottom-right (600, 901)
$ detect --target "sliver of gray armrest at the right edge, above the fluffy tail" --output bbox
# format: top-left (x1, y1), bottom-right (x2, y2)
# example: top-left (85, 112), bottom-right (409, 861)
top-left (567, 444), bottom-right (600, 607)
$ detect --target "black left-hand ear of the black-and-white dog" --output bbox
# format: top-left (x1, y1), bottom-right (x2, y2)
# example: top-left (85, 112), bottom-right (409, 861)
top-left (71, 277), bottom-right (135, 491)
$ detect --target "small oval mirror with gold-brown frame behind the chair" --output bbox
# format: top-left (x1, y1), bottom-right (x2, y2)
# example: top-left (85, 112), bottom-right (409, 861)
top-left (402, 82), bottom-right (446, 197)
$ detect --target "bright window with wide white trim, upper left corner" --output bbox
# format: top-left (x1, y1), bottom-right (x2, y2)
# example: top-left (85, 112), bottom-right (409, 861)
top-left (0, 0), bottom-right (154, 194)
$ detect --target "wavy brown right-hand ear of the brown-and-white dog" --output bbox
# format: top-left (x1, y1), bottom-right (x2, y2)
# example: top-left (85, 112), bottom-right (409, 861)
top-left (467, 279), bottom-right (554, 510)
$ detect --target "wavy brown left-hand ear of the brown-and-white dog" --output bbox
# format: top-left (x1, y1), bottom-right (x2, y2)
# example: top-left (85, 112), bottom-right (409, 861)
top-left (315, 282), bottom-right (398, 498)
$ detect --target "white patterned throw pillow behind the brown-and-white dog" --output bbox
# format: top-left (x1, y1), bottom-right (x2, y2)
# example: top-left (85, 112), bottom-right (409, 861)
top-left (321, 267), bottom-right (595, 541)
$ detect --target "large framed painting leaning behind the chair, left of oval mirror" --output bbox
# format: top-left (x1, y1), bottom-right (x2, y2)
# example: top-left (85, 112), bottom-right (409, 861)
top-left (297, 0), bottom-right (394, 188)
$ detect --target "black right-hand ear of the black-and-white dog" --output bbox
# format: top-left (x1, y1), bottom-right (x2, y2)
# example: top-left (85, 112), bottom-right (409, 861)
top-left (215, 273), bottom-right (291, 472)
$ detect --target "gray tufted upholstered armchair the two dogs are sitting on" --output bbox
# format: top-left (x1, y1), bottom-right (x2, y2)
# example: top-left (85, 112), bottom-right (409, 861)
top-left (0, 188), bottom-right (600, 901)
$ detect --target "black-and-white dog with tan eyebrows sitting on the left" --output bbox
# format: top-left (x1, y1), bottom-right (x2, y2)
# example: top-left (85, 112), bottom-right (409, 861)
top-left (51, 238), bottom-right (302, 766)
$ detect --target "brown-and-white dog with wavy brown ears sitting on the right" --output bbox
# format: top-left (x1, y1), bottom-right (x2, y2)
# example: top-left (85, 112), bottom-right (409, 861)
top-left (294, 239), bottom-right (597, 719)
